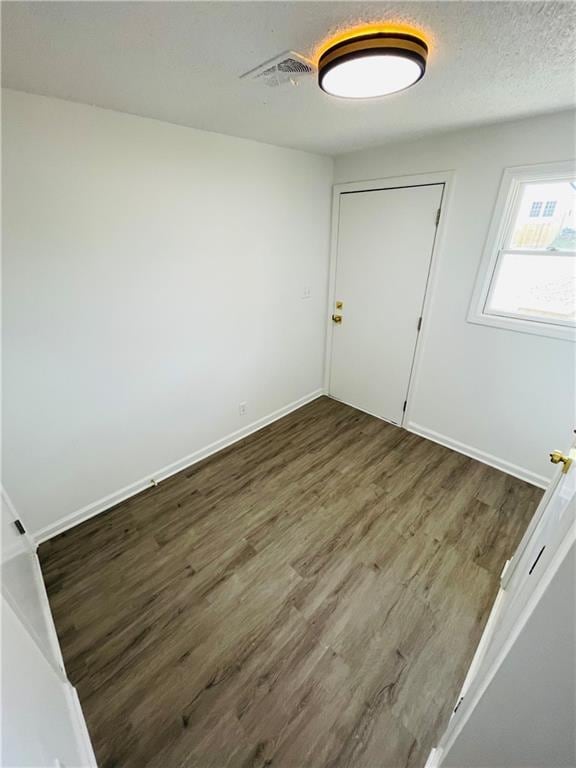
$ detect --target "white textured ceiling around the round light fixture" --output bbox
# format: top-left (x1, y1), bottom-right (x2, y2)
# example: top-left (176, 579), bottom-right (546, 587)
top-left (2, 0), bottom-right (576, 154)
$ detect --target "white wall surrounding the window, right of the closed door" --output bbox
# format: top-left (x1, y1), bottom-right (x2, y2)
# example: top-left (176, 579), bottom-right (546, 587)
top-left (335, 112), bottom-right (576, 484)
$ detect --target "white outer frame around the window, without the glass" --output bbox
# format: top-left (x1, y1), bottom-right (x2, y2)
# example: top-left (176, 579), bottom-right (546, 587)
top-left (468, 160), bottom-right (576, 341)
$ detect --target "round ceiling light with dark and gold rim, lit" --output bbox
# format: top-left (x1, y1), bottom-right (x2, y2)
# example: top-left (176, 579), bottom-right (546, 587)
top-left (318, 32), bottom-right (428, 99)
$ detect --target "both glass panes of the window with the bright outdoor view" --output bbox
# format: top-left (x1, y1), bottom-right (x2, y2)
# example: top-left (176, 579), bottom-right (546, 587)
top-left (484, 179), bottom-right (576, 325)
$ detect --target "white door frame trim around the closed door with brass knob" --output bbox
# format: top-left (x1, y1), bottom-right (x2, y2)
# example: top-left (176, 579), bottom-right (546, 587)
top-left (324, 171), bottom-right (454, 426)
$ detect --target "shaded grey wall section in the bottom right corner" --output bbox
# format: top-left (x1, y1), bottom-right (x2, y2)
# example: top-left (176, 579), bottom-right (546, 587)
top-left (441, 545), bottom-right (576, 768)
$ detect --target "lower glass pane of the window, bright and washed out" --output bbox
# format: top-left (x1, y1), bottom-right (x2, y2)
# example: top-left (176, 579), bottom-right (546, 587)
top-left (486, 253), bottom-right (576, 323)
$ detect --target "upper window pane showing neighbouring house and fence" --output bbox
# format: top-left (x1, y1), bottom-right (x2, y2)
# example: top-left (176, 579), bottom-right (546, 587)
top-left (508, 180), bottom-right (576, 251)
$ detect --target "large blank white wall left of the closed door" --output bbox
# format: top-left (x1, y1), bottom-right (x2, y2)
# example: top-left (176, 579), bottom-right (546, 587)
top-left (3, 91), bottom-right (332, 534)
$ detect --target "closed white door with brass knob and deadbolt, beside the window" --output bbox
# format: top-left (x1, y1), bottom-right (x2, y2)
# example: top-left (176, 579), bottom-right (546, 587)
top-left (330, 184), bottom-right (444, 424)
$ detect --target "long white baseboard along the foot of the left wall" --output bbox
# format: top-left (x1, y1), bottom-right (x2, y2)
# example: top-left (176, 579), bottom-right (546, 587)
top-left (34, 389), bottom-right (324, 545)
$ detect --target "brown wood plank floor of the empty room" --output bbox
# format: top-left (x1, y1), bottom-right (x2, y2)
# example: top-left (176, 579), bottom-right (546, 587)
top-left (40, 398), bottom-right (541, 768)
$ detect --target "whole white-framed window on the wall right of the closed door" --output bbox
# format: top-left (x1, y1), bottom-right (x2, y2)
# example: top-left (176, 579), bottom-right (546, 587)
top-left (468, 163), bottom-right (576, 339)
